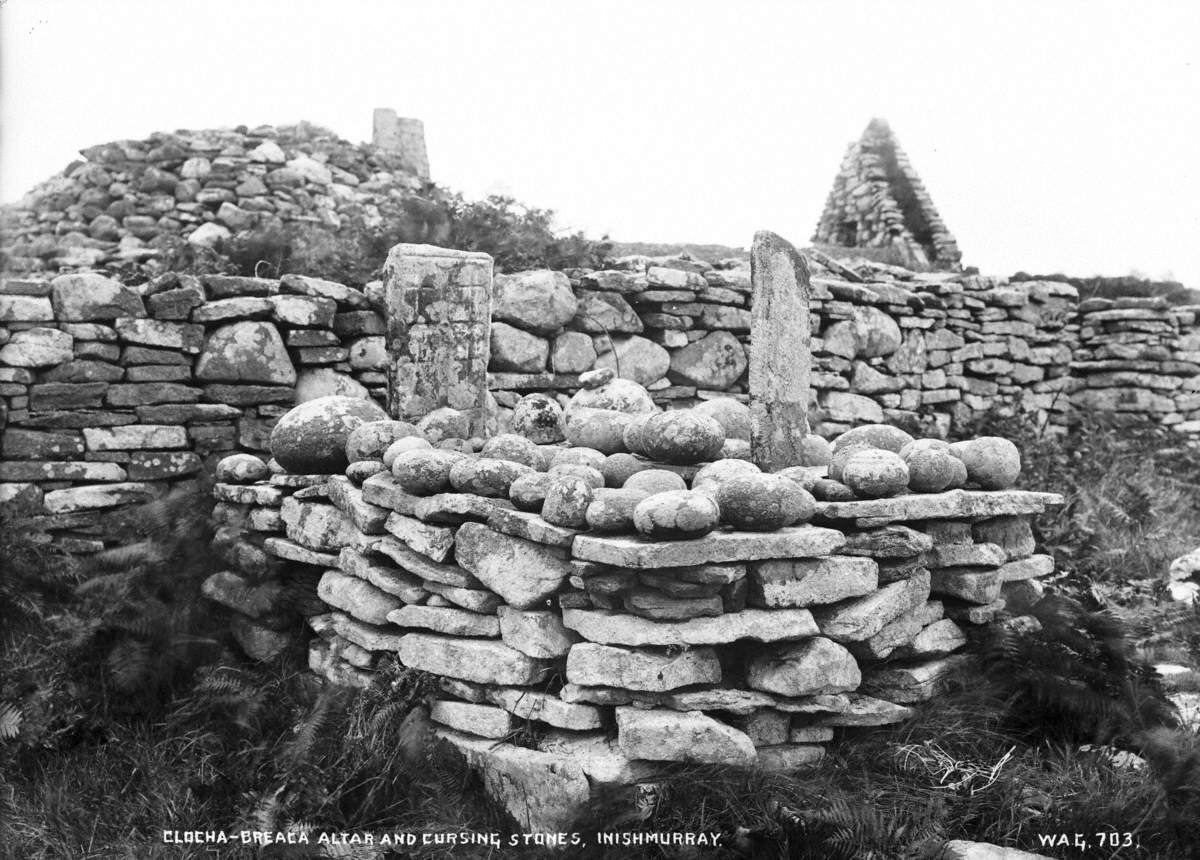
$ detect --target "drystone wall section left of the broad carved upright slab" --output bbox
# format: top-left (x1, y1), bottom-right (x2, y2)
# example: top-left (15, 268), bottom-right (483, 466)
top-left (0, 272), bottom-right (388, 549)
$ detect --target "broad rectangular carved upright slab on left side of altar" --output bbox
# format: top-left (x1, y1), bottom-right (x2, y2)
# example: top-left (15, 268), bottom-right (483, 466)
top-left (383, 245), bottom-right (492, 435)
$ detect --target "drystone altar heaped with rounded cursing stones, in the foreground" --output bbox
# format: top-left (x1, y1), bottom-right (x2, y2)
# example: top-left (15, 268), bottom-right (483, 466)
top-left (206, 236), bottom-right (1061, 830)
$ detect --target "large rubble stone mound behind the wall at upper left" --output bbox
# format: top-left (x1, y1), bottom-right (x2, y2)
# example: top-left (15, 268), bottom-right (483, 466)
top-left (0, 119), bottom-right (428, 272)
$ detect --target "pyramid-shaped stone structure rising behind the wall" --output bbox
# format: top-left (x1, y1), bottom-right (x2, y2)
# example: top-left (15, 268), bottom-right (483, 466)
top-left (812, 119), bottom-right (962, 271)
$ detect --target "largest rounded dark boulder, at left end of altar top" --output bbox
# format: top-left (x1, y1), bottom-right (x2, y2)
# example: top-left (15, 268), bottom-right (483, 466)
top-left (270, 397), bottom-right (388, 475)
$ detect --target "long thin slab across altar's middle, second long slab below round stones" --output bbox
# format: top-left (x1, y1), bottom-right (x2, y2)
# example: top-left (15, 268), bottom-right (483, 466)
top-left (563, 609), bottom-right (818, 645)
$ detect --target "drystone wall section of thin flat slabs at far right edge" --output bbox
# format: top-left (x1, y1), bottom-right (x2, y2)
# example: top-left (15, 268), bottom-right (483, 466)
top-left (1070, 297), bottom-right (1200, 433)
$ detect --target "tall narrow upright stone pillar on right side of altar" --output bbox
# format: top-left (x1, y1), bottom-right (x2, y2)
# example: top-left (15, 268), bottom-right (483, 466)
top-left (750, 230), bottom-right (812, 471)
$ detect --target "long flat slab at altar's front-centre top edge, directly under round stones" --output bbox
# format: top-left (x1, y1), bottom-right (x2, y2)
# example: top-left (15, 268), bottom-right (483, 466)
top-left (571, 525), bottom-right (845, 569)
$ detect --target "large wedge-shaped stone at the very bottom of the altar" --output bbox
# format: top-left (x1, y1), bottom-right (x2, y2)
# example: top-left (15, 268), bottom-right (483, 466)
top-left (434, 728), bottom-right (592, 832)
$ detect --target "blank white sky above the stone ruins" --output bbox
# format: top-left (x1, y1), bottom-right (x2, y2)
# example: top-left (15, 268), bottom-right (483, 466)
top-left (0, 0), bottom-right (1200, 287)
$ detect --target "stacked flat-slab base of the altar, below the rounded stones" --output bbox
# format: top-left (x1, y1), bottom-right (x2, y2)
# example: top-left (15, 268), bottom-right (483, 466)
top-left (217, 422), bottom-right (1061, 826)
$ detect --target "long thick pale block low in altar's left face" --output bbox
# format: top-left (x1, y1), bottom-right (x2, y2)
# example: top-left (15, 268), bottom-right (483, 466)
top-left (400, 633), bottom-right (552, 686)
